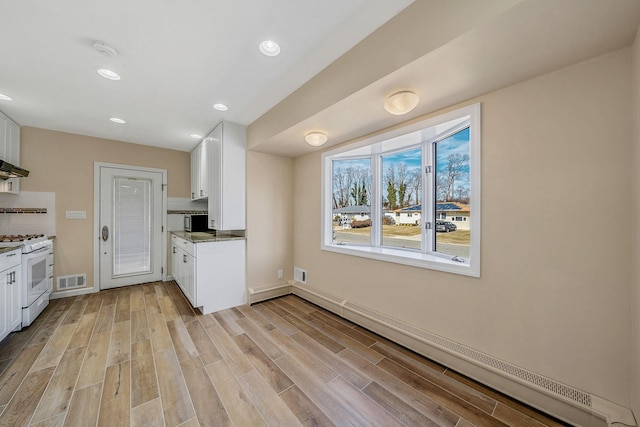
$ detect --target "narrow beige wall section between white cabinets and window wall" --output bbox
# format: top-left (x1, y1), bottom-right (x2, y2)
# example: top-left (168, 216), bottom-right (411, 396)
top-left (247, 151), bottom-right (293, 288)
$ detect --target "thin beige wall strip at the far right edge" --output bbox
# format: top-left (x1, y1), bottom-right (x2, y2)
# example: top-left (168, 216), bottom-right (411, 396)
top-left (631, 25), bottom-right (640, 422)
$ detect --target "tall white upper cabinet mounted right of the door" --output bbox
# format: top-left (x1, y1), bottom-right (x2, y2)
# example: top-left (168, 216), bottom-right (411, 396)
top-left (207, 122), bottom-right (247, 230)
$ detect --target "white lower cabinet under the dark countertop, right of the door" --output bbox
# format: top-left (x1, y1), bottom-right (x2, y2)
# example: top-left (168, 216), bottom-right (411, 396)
top-left (171, 235), bottom-right (246, 314)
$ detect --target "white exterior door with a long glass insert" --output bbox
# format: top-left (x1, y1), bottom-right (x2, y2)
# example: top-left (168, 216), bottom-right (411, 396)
top-left (96, 164), bottom-right (166, 289)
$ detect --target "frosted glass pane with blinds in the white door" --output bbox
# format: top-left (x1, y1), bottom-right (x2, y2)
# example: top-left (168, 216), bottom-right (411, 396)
top-left (111, 178), bottom-right (151, 277)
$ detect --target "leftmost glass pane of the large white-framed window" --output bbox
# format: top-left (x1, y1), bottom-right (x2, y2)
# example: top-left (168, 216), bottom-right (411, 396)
top-left (331, 158), bottom-right (371, 245)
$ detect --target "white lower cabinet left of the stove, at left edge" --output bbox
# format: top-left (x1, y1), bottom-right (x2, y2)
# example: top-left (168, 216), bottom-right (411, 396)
top-left (0, 248), bottom-right (22, 341)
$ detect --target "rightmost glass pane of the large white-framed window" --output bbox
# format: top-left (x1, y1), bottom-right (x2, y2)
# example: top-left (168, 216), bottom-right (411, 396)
top-left (435, 128), bottom-right (471, 259)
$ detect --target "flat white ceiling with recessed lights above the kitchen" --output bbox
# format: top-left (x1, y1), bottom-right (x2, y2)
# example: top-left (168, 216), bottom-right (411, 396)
top-left (0, 0), bottom-right (413, 151)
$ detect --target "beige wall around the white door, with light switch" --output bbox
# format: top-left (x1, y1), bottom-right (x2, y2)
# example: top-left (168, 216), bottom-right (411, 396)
top-left (20, 126), bottom-right (191, 286)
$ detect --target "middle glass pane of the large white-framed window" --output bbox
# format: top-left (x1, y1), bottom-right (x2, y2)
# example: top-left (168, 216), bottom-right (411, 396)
top-left (381, 147), bottom-right (422, 250)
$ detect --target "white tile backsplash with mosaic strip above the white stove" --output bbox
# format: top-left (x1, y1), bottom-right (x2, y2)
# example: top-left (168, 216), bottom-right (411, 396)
top-left (0, 191), bottom-right (56, 236)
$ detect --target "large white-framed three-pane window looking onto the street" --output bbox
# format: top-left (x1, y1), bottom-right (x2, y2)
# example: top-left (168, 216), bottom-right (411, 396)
top-left (322, 104), bottom-right (480, 276)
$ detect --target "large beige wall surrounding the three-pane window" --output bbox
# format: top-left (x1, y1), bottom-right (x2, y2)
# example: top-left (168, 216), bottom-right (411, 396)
top-left (293, 49), bottom-right (633, 407)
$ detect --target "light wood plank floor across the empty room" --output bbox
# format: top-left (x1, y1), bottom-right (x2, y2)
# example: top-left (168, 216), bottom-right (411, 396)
top-left (0, 282), bottom-right (559, 427)
